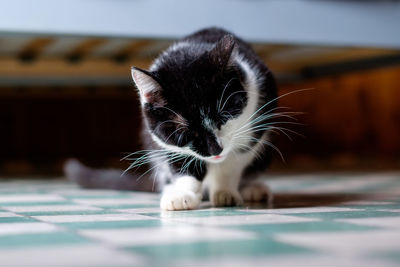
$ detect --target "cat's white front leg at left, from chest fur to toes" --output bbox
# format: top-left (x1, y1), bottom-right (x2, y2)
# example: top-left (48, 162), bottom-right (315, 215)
top-left (160, 176), bottom-right (202, 210)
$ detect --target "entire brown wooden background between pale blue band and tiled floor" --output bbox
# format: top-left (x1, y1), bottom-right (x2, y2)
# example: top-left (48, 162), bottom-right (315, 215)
top-left (0, 36), bottom-right (400, 175)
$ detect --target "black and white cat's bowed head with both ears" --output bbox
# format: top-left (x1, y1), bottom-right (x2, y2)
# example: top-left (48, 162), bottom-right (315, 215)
top-left (132, 35), bottom-right (255, 162)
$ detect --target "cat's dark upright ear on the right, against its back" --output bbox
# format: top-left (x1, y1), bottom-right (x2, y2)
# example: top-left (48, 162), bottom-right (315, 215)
top-left (209, 34), bottom-right (235, 67)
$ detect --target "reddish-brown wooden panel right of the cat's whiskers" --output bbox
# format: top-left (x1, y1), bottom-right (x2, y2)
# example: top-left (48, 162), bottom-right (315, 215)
top-left (280, 67), bottom-right (400, 156)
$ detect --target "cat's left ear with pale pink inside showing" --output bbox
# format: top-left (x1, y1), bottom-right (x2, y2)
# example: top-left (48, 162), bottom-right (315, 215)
top-left (131, 67), bottom-right (165, 106)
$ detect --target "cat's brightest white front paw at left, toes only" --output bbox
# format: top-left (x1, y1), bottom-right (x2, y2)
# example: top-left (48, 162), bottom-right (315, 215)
top-left (160, 190), bottom-right (201, 210)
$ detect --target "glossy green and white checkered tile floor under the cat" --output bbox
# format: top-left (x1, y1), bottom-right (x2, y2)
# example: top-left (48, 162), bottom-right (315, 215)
top-left (0, 173), bottom-right (400, 267)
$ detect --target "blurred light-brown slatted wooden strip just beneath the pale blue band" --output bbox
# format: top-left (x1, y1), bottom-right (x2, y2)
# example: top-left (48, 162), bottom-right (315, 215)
top-left (0, 35), bottom-right (400, 86)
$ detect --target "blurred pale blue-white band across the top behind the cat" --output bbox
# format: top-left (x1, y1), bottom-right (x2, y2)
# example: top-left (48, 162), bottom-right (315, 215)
top-left (0, 0), bottom-right (400, 48)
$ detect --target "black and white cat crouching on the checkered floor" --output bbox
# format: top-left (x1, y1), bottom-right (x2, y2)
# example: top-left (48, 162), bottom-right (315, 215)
top-left (65, 28), bottom-right (277, 210)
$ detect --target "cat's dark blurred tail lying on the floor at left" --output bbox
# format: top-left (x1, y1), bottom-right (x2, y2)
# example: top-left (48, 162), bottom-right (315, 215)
top-left (64, 159), bottom-right (157, 192)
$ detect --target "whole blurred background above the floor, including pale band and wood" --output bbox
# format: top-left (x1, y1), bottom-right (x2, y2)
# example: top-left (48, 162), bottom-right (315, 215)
top-left (0, 0), bottom-right (400, 177)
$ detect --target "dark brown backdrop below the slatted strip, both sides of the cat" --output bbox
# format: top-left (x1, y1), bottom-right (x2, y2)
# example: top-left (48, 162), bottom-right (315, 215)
top-left (0, 64), bottom-right (400, 174)
